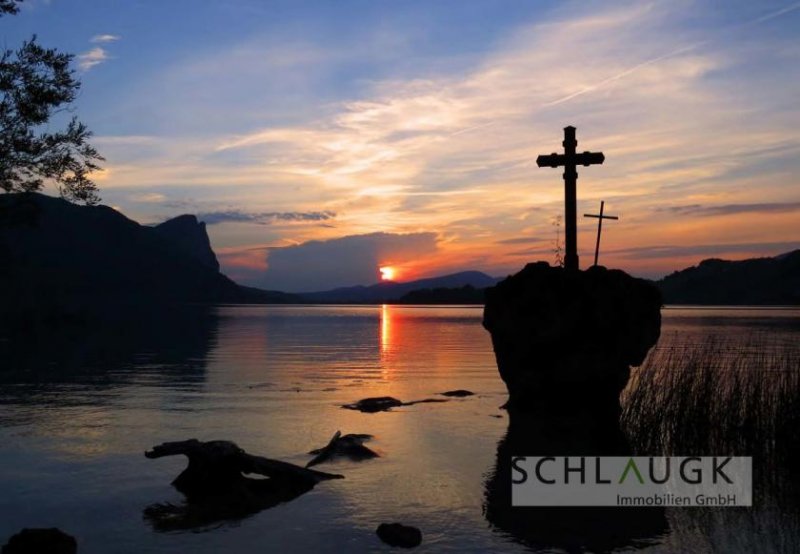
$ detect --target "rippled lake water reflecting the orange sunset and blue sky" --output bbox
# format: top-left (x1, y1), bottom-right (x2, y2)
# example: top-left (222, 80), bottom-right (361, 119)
top-left (0, 306), bottom-right (800, 553)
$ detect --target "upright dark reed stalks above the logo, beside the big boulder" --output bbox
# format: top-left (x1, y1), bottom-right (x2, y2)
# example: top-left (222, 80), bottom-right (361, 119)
top-left (622, 333), bottom-right (800, 461)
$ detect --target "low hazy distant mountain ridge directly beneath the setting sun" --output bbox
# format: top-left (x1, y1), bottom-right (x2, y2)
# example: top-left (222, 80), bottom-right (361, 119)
top-left (297, 271), bottom-right (499, 304)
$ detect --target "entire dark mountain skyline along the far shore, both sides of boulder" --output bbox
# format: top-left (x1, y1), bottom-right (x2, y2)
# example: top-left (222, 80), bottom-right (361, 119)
top-left (0, 193), bottom-right (800, 308)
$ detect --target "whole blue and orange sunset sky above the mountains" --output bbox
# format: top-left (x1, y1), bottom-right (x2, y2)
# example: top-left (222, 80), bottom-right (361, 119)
top-left (7, 0), bottom-right (800, 291)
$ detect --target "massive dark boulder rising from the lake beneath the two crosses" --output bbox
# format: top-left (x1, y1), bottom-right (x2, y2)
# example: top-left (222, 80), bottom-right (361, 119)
top-left (483, 262), bottom-right (661, 421)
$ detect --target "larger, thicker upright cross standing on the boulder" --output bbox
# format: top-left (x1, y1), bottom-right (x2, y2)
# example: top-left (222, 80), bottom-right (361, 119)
top-left (536, 125), bottom-right (606, 271)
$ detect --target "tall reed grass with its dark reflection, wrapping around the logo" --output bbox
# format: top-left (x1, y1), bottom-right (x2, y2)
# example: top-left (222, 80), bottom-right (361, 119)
top-left (621, 332), bottom-right (800, 554)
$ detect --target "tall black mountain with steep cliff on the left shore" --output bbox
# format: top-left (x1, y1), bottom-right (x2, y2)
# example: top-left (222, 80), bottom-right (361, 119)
top-left (0, 193), bottom-right (294, 313)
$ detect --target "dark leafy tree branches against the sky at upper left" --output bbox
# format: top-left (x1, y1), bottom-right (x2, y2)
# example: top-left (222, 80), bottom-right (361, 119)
top-left (0, 0), bottom-right (103, 204)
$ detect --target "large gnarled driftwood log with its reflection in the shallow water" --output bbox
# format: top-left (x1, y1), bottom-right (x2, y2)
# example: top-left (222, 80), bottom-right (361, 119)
top-left (144, 439), bottom-right (342, 530)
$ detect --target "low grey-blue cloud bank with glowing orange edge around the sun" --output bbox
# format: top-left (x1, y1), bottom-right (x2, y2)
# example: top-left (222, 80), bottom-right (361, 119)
top-left (249, 233), bottom-right (437, 292)
